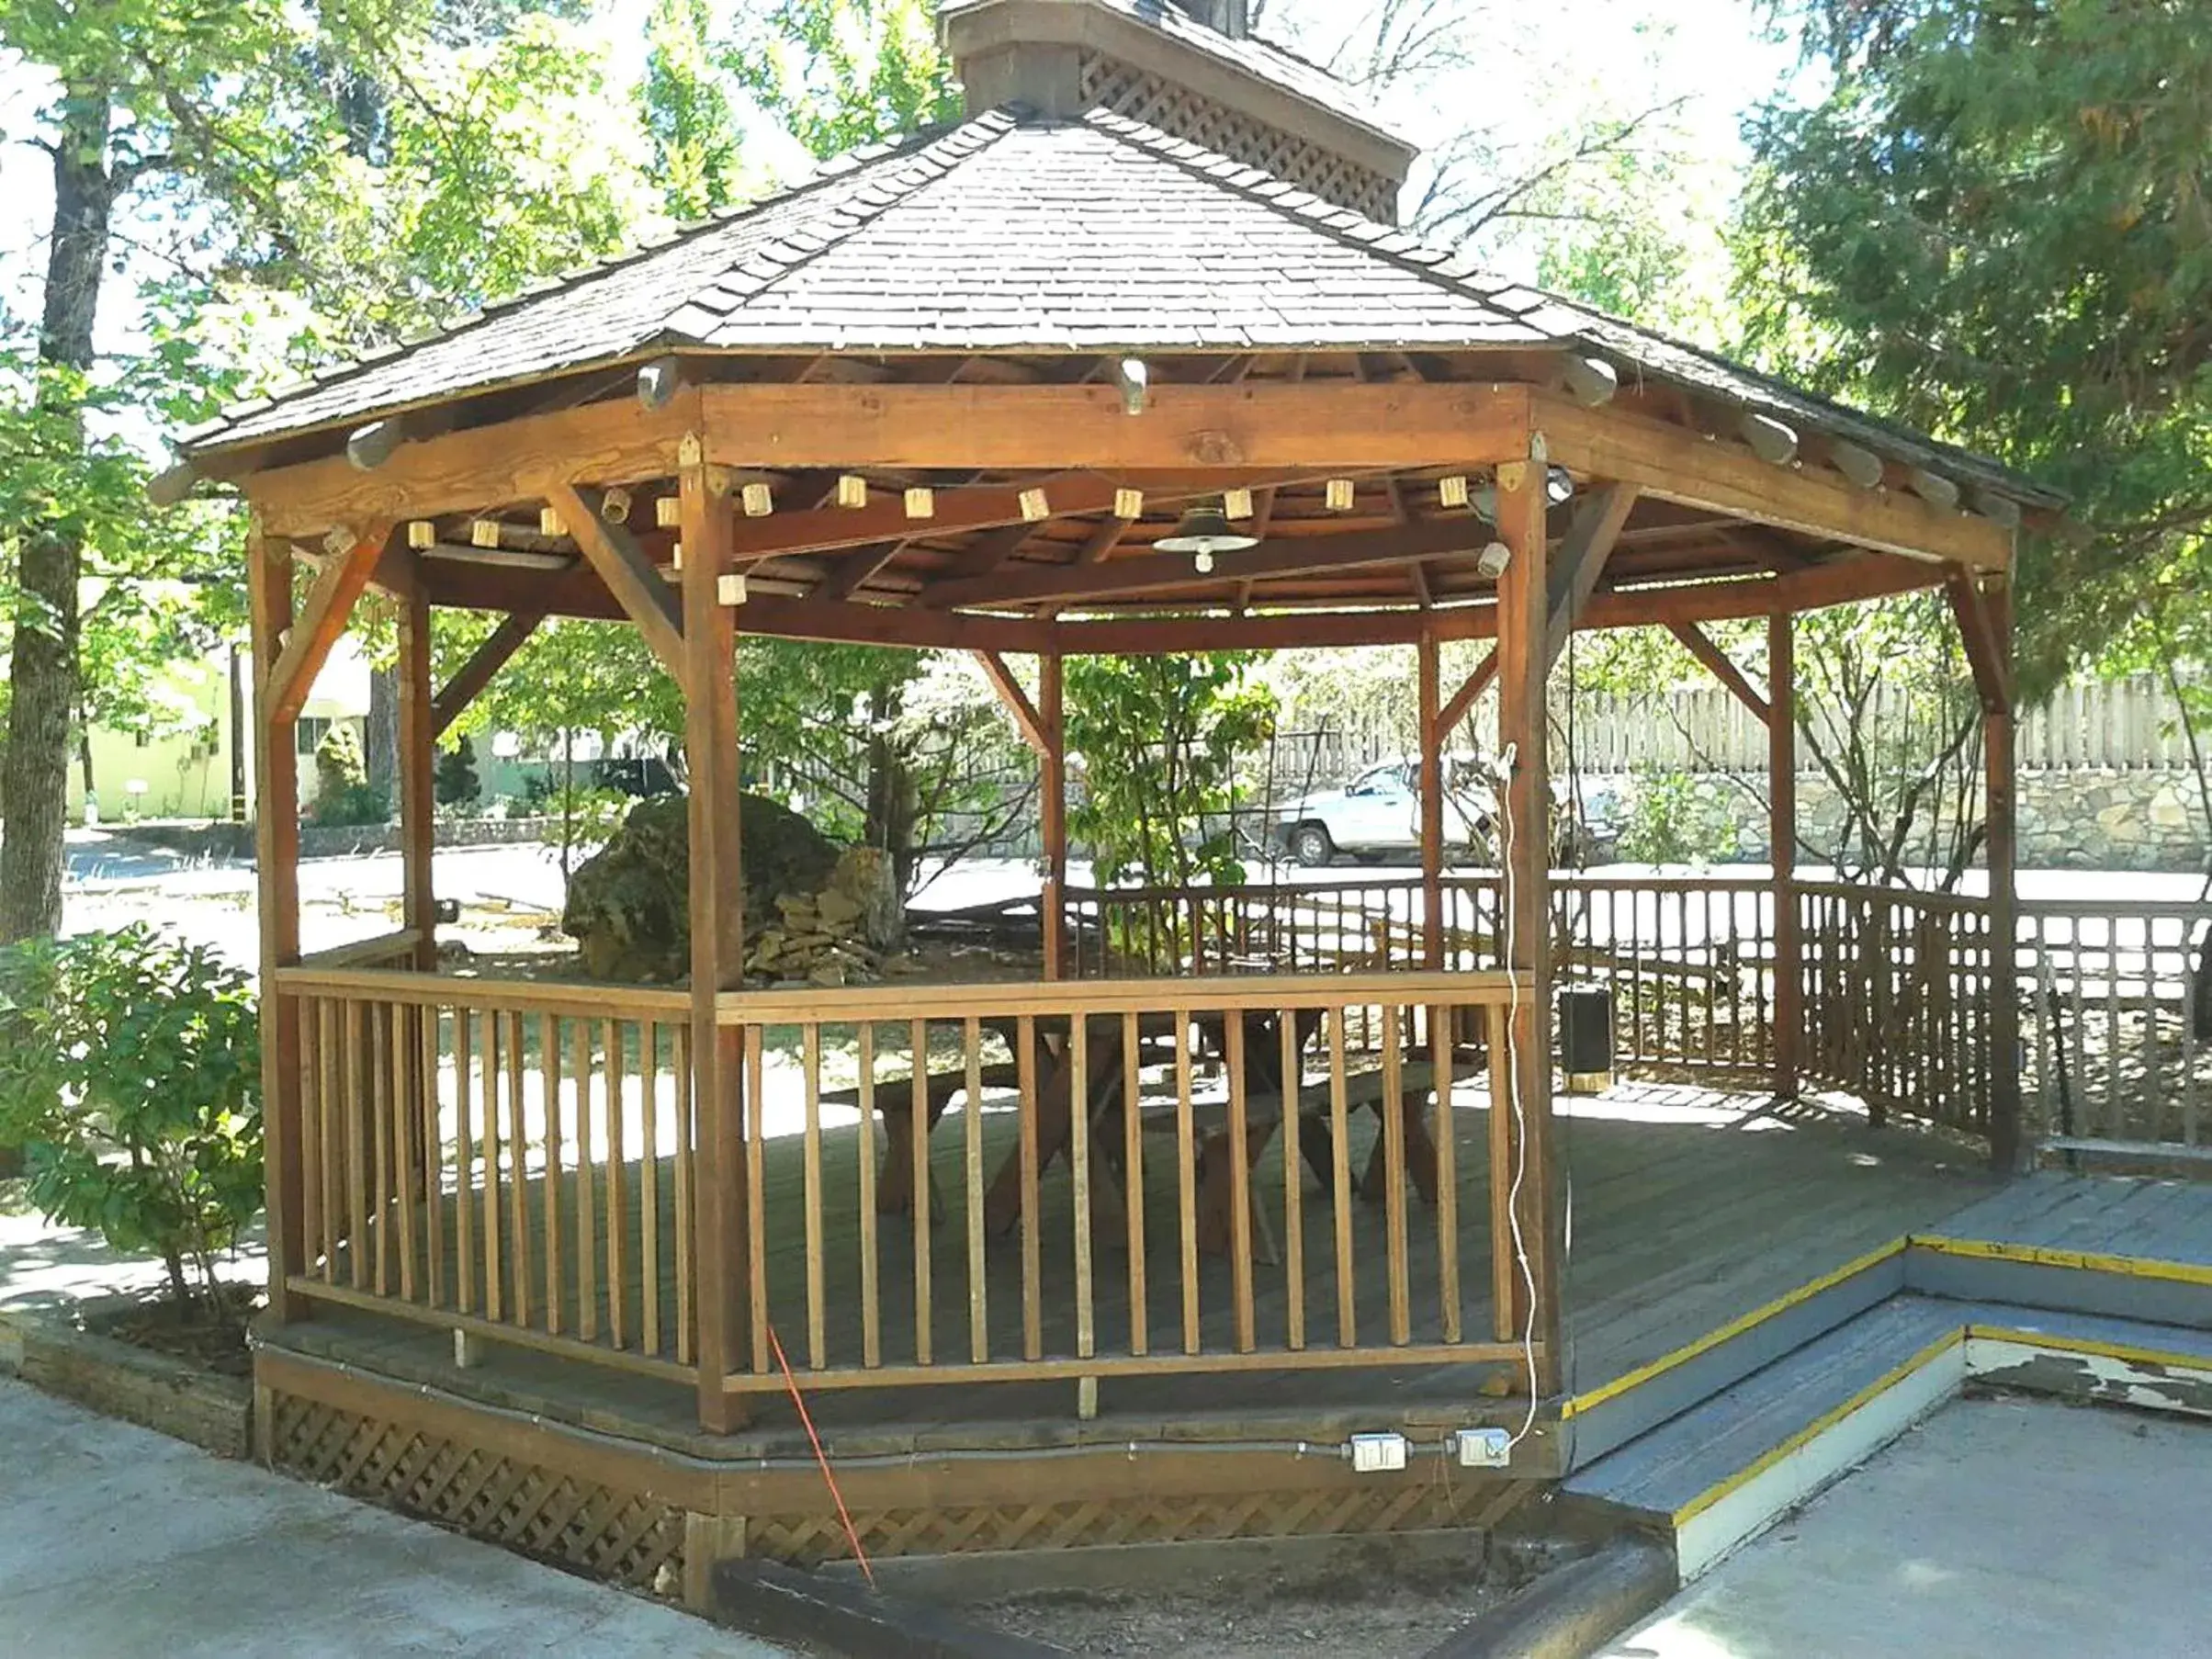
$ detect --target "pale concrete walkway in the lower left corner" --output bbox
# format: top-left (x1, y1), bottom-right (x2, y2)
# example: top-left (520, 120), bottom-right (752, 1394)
top-left (0, 1378), bottom-right (781, 1659)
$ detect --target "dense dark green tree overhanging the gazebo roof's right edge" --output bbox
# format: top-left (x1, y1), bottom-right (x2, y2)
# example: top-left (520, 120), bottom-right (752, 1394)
top-left (1741, 0), bottom-right (2212, 694)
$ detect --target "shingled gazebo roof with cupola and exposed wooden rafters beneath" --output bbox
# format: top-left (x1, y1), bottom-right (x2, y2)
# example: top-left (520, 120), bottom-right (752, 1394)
top-left (181, 0), bottom-right (2057, 641)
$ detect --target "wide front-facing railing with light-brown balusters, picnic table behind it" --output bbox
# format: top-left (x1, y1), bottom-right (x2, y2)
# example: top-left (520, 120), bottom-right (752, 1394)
top-left (728, 976), bottom-right (1519, 1392)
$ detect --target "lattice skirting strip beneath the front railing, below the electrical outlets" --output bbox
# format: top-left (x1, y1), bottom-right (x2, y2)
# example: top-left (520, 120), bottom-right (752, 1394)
top-left (745, 1480), bottom-right (1538, 1566)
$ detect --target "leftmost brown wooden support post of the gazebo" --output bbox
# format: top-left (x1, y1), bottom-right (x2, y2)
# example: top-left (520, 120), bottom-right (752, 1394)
top-left (245, 533), bottom-right (308, 1325)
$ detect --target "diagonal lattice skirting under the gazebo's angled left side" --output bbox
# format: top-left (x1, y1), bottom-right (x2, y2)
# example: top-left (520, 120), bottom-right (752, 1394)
top-left (267, 1394), bottom-right (683, 1595)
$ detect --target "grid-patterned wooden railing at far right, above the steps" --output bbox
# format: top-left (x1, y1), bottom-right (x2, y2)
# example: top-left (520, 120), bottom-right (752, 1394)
top-left (2020, 900), bottom-right (2212, 1157)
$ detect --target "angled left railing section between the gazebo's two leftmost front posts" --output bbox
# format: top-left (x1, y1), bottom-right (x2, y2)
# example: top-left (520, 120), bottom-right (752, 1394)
top-left (278, 966), bottom-right (697, 1378)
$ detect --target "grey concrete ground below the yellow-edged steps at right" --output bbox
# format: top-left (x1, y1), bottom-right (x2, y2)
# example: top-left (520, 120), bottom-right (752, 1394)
top-left (1604, 1400), bottom-right (2212, 1659)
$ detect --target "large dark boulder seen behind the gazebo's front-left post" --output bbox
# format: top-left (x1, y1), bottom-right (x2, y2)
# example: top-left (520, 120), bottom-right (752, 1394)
top-left (562, 794), bottom-right (902, 985)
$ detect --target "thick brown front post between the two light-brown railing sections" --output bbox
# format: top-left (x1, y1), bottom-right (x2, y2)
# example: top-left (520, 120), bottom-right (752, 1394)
top-left (663, 438), bottom-right (759, 1433)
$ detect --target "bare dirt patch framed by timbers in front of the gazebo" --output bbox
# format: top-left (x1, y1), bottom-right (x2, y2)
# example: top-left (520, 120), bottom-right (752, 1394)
top-left (966, 1557), bottom-right (1535, 1659)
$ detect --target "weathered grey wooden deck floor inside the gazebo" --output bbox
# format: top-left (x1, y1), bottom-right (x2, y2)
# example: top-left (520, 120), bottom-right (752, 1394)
top-left (283, 1086), bottom-right (1993, 1455)
